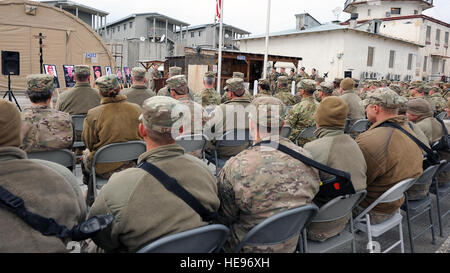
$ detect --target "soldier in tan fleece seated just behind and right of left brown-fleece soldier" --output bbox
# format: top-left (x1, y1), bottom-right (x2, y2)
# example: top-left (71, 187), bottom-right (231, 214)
top-left (121, 67), bottom-right (156, 106)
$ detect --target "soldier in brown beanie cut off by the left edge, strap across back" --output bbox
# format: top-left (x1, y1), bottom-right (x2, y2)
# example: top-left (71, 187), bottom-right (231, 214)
top-left (0, 99), bottom-right (87, 253)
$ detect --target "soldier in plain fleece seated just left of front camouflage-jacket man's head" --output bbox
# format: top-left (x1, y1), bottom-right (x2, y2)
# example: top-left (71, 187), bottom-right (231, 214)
top-left (205, 78), bottom-right (251, 158)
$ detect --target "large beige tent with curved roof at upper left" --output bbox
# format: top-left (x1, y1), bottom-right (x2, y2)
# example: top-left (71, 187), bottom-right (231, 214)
top-left (0, 0), bottom-right (115, 91)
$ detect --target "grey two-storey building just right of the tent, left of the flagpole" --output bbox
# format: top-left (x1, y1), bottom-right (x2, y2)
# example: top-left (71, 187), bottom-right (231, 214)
top-left (102, 13), bottom-right (189, 67)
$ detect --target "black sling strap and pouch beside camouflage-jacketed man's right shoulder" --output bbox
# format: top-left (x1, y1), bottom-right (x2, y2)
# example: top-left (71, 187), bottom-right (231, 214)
top-left (253, 141), bottom-right (356, 199)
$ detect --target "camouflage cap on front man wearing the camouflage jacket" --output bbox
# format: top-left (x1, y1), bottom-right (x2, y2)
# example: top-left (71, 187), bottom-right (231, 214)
top-left (249, 97), bottom-right (285, 128)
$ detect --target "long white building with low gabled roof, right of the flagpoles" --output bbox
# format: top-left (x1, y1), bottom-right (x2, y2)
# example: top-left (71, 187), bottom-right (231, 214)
top-left (237, 14), bottom-right (423, 80)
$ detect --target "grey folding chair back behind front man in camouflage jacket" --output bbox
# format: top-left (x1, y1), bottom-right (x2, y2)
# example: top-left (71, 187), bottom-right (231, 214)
top-left (234, 204), bottom-right (319, 253)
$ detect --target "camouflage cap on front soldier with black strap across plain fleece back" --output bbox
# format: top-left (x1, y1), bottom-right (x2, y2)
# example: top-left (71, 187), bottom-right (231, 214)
top-left (139, 96), bottom-right (186, 133)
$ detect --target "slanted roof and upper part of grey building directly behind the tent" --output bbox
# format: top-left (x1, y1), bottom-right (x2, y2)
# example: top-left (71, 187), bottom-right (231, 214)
top-left (41, 0), bottom-right (109, 33)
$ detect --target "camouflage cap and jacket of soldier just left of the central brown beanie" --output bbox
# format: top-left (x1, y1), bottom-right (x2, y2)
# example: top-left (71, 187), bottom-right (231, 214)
top-left (286, 80), bottom-right (319, 146)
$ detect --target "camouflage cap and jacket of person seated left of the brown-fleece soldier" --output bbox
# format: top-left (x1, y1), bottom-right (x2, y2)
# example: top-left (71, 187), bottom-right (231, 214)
top-left (21, 75), bottom-right (74, 153)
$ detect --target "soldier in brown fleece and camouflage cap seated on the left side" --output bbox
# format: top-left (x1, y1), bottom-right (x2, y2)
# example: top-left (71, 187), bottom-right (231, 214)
top-left (81, 75), bottom-right (141, 204)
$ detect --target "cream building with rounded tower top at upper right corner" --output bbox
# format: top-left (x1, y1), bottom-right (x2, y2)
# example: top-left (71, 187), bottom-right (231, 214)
top-left (344, 0), bottom-right (450, 80)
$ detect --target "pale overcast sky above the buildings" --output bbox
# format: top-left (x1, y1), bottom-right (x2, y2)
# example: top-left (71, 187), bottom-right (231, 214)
top-left (40, 0), bottom-right (450, 35)
